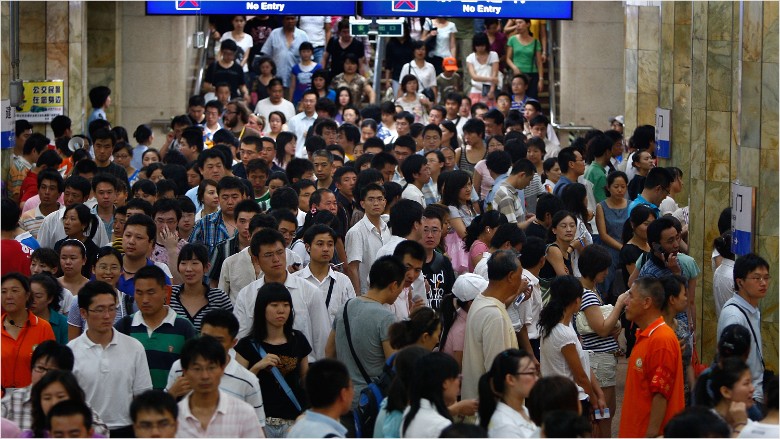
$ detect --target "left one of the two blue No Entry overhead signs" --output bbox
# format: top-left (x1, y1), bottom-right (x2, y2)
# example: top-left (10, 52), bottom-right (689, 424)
top-left (146, 0), bottom-right (355, 16)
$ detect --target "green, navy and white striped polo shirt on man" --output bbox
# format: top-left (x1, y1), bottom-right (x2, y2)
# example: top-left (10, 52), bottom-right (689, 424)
top-left (115, 308), bottom-right (197, 390)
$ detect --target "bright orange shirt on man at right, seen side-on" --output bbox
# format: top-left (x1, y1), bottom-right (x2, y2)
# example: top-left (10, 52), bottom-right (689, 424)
top-left (619, 317), bottom-right (685, 437)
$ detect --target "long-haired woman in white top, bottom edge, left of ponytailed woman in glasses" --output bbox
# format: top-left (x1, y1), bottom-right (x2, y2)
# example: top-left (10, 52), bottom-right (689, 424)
top-left (400, 352), bottom-right (460, 437)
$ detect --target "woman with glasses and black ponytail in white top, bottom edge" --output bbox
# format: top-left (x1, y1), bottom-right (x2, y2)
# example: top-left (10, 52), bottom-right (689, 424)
top-left (479, 349), bottom-right (539, 437)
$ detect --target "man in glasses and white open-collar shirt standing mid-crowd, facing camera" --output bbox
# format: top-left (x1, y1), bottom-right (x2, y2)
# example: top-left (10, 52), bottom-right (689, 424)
top-left (345, 183), bottom-right (390, 295)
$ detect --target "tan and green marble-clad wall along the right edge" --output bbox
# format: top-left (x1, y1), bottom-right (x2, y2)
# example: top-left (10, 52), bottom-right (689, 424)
top-left (625, 1), bottom-right (780, 370)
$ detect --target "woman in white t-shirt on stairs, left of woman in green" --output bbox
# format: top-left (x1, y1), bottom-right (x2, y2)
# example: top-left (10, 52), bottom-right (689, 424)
top-left (466, 34), bottom-right (499, 107)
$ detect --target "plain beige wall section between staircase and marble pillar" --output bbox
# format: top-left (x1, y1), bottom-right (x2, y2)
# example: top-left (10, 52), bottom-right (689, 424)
top-left (557, 1), bottom-right (624, 130)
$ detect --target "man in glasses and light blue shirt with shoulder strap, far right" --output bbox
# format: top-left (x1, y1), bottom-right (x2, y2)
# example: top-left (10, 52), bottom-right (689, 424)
top-left (717, 253), bottom-right (772, 420)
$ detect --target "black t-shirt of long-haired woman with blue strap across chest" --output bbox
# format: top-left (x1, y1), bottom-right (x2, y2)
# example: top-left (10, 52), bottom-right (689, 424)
top-left (236, 330), bottom-right (311, 419)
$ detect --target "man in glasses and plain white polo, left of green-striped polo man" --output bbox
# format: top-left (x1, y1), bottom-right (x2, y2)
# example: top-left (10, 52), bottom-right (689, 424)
top-left (68, 281), bottom-right (152, 437)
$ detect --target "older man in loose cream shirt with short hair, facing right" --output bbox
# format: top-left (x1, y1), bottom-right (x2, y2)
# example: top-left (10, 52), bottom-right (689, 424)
top-left (461, 250), bottom-right (528, 399)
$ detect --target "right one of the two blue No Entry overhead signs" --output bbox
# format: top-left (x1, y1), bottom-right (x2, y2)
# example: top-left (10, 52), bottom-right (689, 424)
top-left (360, 0), bottom-right (572, 20)
